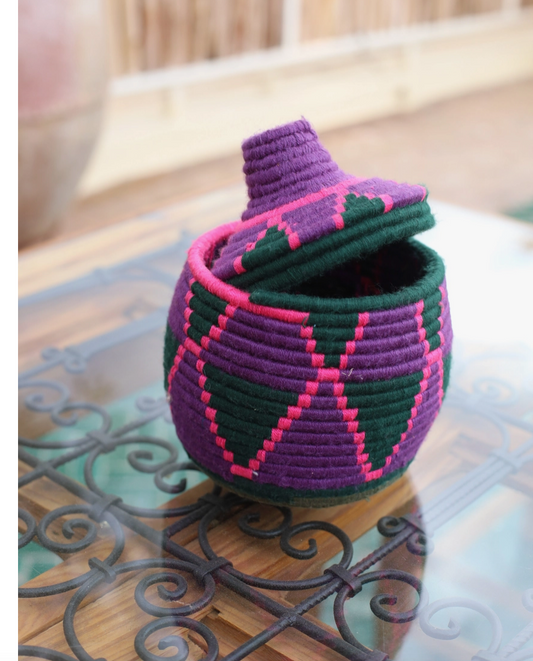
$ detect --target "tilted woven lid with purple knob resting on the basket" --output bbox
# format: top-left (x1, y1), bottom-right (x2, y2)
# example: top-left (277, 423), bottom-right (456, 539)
top-left (212, 119), bottom-right (435, 291)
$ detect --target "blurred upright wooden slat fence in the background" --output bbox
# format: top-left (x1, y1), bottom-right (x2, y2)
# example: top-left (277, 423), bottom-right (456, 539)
top-left (104, 0), bottom-right (533, 77)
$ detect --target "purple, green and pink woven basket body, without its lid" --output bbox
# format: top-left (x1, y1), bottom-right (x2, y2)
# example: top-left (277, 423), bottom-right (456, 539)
top-left (166, 232), bottom-right (452, 507)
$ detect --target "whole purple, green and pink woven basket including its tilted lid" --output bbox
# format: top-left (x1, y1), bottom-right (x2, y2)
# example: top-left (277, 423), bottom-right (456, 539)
top-left (164, 119), bottom-right (452, 507)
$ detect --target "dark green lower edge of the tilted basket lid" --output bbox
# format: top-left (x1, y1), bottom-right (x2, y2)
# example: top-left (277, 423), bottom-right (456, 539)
top-left (228, 198), bottom-right (435, 291)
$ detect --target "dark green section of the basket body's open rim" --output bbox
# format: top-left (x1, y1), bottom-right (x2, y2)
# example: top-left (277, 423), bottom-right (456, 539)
top-left (250, 240), bottom-right (444, 314)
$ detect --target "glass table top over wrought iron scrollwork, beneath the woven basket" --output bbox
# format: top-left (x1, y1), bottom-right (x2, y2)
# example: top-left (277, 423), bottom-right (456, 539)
top-left (19, 197), bottom-right (533, 661)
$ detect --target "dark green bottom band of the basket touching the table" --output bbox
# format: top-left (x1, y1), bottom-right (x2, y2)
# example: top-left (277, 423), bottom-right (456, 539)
top-left (190, 457), bottom-right (411, 508)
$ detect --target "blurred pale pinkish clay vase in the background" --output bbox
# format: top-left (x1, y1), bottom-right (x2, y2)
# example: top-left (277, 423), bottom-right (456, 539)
top-left (19, 0), bottom-right (107, 247)
